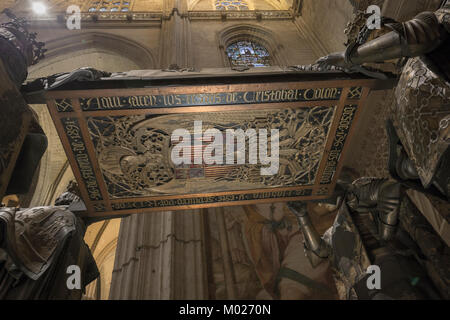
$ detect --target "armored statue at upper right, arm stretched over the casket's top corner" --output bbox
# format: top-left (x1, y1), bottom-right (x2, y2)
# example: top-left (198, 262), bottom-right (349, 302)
top-left (317, 1), bottom-right (450, 200)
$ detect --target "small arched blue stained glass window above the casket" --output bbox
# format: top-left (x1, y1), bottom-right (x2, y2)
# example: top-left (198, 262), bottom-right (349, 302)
top-left (226, 41), bottom-right (270, 67)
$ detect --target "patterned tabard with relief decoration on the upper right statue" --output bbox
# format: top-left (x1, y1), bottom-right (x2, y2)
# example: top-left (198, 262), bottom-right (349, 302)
top-left (390, 58), bottom-right (450, 185)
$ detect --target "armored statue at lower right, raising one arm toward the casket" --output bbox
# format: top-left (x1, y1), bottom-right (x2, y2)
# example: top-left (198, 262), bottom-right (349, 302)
top-left (288, 178), bottom-right (450, 300)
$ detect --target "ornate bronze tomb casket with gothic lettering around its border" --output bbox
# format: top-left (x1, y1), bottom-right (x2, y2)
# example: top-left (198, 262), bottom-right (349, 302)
top-left (46, 71), bottom-right (392, 217)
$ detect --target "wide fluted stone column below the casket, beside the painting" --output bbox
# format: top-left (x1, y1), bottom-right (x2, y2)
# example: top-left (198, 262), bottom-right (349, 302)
top-left (110, 210), bottom-right (208, 300)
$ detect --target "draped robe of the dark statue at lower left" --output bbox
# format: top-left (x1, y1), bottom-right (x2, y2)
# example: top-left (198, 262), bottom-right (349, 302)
top-left (0, 207), bottom-right (99, 299)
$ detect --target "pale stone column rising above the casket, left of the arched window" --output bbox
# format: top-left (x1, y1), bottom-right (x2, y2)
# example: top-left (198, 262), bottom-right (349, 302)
top-left (159, 0), bottom-right (193, 69)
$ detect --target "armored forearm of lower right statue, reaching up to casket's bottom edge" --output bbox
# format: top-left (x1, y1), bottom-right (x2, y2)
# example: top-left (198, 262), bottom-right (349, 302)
top-left (287, 202), bottom-right (328, 267)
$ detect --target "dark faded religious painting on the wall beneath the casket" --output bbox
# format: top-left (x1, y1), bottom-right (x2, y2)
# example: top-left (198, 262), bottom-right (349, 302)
top-left (206, 203), bottom-right (338, 300)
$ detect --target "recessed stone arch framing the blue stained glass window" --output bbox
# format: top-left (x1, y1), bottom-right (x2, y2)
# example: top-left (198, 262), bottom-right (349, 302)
top-left (217, 24), bottom-right (287, 67)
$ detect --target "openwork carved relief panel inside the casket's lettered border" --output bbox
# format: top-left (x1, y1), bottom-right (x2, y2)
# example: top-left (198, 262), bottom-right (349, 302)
top-left (88, 107), bottom-right (335, 198)
